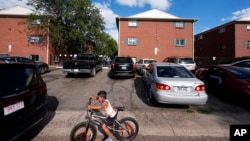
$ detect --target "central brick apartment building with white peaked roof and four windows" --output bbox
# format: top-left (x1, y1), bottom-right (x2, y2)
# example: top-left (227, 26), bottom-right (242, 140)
top-left (116, 9), bottom-right (197, 61)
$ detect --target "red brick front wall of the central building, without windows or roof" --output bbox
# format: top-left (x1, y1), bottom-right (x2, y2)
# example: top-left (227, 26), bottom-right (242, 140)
top-left (118, 20), bottom-right (193, 61)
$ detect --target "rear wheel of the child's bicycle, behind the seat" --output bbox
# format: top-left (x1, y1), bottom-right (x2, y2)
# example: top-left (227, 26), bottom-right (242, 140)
top-left (115, 117), bottom-right (139, 141)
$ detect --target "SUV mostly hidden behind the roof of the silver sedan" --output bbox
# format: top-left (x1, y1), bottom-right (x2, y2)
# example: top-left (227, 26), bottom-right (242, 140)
top-left (163, 56), bottom-right (196, 71)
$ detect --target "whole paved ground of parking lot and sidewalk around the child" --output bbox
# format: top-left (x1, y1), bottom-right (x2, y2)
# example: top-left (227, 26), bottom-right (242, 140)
top-left (20, 68), bottom-right (250, 141)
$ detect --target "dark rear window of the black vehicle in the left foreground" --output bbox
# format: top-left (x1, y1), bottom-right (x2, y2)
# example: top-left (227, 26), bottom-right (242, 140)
top-left (0, 65), bottom-right (37, 98)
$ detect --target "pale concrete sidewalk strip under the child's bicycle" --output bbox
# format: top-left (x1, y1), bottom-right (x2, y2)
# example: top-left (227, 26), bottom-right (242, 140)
top-left (33, 111), bottom-right (229, 141)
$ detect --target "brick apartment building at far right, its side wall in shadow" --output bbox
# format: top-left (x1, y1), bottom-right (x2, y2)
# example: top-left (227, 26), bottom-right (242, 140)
top-left (194, 17), bottom-right (250, 66)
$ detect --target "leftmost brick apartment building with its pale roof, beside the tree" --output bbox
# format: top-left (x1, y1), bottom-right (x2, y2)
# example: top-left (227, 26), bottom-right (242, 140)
top-left (0, 6), bottom-right (55, 64)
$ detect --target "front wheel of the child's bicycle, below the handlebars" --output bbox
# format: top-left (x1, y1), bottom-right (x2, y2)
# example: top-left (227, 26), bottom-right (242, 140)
top-left (70, 122), bottom-right (97, 141)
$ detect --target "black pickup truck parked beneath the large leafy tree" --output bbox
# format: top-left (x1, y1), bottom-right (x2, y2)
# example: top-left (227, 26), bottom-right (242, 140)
top-left (63, 53), bottom-right (103, 77)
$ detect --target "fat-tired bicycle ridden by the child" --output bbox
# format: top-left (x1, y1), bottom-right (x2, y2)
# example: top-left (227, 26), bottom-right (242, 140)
top-left (70, 98), bottom-right (139, 141)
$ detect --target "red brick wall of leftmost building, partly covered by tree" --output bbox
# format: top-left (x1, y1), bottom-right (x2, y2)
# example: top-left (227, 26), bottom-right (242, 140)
top-left (0, 17), bottom-right (50, 64)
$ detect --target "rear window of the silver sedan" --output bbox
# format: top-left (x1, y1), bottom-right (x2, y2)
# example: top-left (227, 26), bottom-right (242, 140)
top-left (157, 66), bottom-right (194, 78)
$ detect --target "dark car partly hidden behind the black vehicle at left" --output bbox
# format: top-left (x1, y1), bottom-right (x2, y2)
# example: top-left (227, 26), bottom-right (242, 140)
top-left (0, 56), bottom-right (49, 74)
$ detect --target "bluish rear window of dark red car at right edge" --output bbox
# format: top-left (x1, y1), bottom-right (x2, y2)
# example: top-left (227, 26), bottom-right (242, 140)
top-left (229, 68), bottom-right (250, 79)
